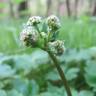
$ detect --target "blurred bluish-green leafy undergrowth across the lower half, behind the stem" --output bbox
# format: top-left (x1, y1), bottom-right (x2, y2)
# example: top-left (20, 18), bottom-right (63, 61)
top-left (0, 47), bottom-right (96, 96)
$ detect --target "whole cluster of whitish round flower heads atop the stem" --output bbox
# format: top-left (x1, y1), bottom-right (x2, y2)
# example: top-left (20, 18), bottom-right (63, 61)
top-left (20, 15), bottom-right (65, 55)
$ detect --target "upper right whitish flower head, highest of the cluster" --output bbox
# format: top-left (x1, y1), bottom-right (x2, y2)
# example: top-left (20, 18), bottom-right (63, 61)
top-left (47, 15), bottom-right (60, 30)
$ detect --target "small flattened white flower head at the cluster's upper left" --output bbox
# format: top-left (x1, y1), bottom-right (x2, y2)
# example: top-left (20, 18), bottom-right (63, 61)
top-left (27, 16), bottom-right (42, 26)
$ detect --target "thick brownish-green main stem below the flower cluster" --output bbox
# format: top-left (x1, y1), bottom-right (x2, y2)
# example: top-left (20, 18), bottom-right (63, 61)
top-left (47, 51), bottom-right (72, 96)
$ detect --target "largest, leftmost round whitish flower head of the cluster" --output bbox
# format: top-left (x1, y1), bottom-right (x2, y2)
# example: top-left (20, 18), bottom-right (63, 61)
top-left (20, 27), bottom-right (39, 47)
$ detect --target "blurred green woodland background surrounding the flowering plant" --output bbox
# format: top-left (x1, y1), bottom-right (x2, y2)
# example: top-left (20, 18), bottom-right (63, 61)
top-left (0, 0), bottom-right (96, 96)
